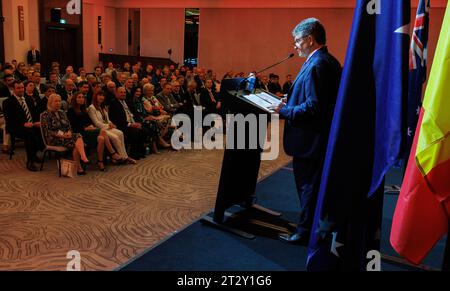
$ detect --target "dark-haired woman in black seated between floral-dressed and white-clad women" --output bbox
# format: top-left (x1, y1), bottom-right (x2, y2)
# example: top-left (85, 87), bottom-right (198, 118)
top-left (67, 92), bottom-right (120, 172)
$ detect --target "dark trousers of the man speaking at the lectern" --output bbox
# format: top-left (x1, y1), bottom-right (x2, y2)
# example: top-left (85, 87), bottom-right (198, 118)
top-left (293, 157), bottom-right (323, 236)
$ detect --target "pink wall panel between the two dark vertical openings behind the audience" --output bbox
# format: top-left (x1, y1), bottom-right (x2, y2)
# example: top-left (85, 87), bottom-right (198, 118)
top-left (141, 8), bottom-right (185, 63)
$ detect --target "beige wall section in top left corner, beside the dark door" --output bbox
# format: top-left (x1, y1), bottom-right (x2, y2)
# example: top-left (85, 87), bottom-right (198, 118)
top-left (2, 0), bottom-right (39, 62)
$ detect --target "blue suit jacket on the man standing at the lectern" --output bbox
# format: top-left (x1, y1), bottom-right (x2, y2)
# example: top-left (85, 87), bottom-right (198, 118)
top-left (280, 47), bottom-right (342, 158)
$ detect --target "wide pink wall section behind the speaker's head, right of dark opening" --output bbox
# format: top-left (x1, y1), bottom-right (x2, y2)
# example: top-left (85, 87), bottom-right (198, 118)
top-left (199, 8), bottom-right (353, 81)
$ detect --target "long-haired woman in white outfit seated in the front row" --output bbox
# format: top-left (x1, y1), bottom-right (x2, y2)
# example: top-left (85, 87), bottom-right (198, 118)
top-left (87, 92), bottom-right (136, 164)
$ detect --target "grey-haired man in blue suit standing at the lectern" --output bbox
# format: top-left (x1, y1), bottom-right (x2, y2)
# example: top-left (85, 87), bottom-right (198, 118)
top-left (277, 18), bottom-right (342, 245)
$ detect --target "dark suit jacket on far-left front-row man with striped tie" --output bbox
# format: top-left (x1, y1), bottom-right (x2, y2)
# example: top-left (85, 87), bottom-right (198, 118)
top-left (3, 95), bottom-right (39, 133)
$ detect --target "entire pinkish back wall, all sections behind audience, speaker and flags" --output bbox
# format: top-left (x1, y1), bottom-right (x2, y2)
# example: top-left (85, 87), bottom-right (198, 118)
top-left (84, 0), bottom-right (447, 80)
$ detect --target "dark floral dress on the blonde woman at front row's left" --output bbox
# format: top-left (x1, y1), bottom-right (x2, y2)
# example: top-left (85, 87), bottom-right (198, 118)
top-left (41, 110), bottom-right (81, 149)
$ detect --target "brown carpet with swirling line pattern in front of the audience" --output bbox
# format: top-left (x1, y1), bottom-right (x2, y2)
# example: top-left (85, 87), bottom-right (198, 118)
top-left (0, 125), bottom-right (290, 270)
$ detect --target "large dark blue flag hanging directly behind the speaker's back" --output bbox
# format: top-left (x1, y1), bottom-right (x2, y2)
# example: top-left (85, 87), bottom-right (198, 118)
top-left (307, 0), bottom-right (411, 271)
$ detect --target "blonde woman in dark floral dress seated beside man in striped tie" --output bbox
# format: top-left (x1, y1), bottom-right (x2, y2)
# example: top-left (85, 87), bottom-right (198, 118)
top-left (41, 94), bottom-right (89, 175)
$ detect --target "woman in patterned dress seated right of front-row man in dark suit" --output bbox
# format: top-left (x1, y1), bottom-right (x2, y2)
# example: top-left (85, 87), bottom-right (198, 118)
top-left (143, 84), bottom-right (172, 148)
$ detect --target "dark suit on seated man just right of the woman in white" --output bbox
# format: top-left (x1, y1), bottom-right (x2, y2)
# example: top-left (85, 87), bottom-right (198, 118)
top-left (108, 98), bottom-right (150, 159)
